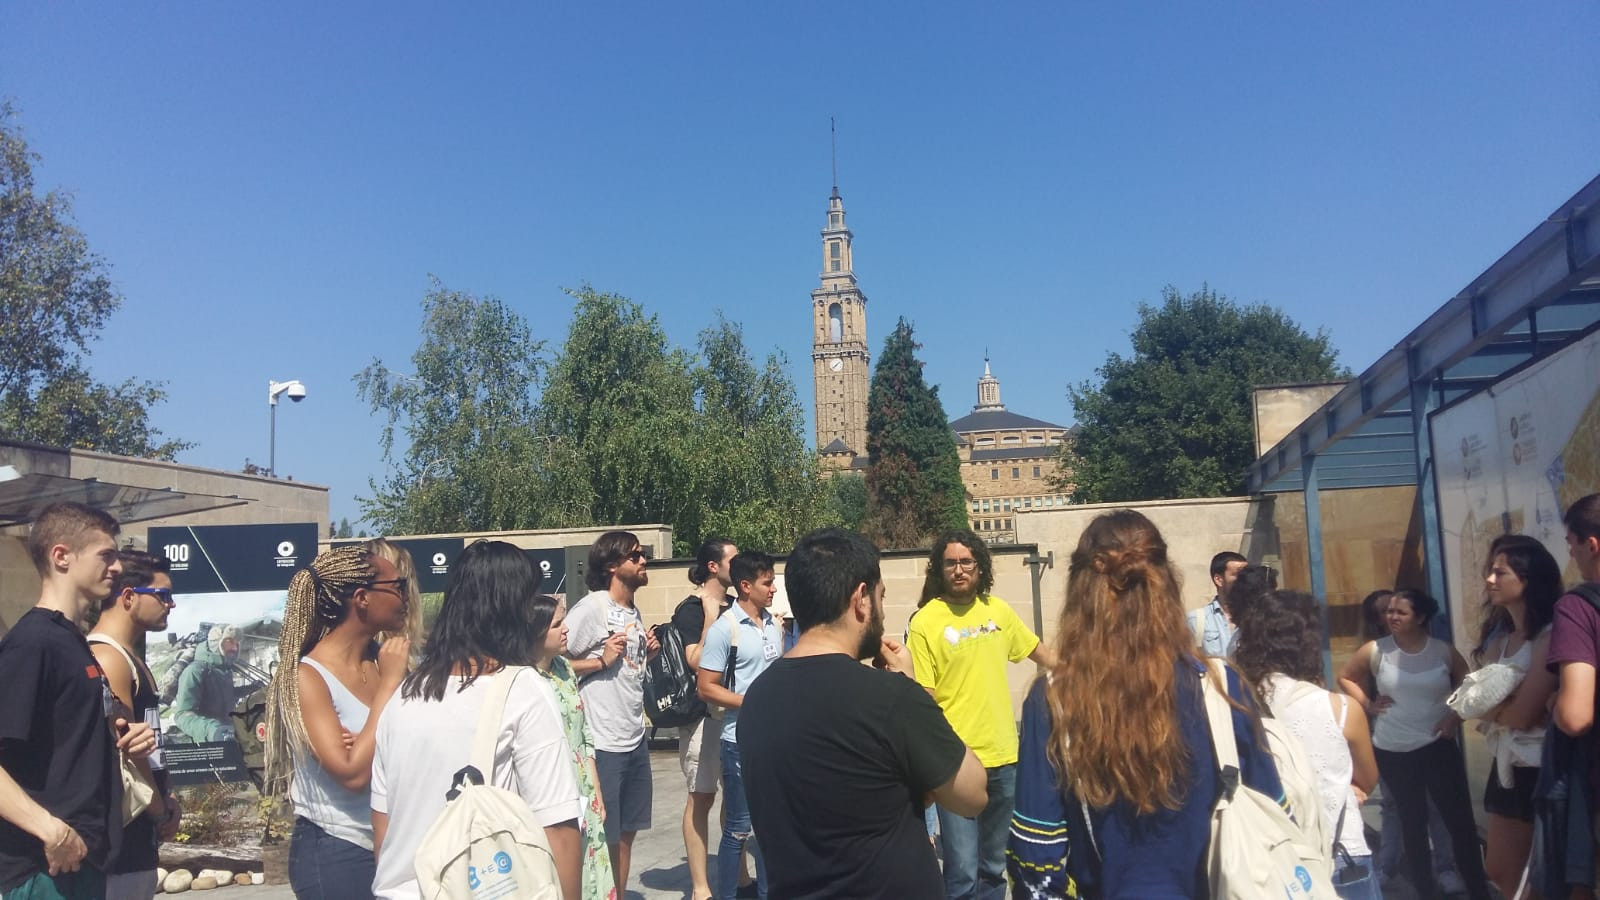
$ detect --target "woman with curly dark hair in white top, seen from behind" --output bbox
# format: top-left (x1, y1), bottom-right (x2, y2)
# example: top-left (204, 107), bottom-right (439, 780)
top-left (1230, 591), bottom-right (1381, 900)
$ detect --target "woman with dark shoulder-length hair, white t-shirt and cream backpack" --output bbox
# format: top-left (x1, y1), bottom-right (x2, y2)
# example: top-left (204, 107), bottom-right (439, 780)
top-left (371, 541), bottom-right (581, 900)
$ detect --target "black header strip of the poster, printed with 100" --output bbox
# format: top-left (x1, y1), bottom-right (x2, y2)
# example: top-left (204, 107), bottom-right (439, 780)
top-left (147, 522), bottom-right (317, 594)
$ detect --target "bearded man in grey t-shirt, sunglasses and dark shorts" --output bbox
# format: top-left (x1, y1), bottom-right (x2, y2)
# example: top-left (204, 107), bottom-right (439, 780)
top-left (566, 532), bottom-right (661, 897)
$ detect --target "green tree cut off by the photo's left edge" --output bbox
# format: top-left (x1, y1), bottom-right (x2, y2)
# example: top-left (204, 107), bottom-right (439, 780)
top-left (0, 102), bottom-right (192, 460)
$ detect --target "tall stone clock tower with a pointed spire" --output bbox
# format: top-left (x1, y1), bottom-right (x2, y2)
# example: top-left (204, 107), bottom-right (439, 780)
top-left (811, 184), bottom-right (870, 469)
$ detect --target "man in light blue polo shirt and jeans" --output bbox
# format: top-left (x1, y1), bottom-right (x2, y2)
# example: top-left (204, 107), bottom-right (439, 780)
top-left (698, 551), bottom-right (784, 900)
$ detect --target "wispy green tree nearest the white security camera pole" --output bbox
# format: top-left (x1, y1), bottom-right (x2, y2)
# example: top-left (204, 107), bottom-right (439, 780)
top-left (355, 279), bottom-right (544, 533)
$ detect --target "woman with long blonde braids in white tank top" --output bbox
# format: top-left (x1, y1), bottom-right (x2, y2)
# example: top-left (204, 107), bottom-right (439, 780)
top-left (266, 546), bottom-right (411, 900)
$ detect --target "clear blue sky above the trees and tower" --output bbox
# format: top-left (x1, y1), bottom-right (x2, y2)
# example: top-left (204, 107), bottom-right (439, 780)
top-left (0, 0), bottom-right (1600, 519)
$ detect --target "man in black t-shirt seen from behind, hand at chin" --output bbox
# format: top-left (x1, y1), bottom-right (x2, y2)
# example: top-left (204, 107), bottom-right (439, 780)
top-left (738, 528), bottom-right (987, 900)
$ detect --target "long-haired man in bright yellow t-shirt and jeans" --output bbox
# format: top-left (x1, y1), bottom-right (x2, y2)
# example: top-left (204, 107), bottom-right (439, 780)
top-left (909, 532), bottom-right (1054, 900)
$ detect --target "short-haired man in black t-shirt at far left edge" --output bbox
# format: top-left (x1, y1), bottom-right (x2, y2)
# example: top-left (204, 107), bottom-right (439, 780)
top-left (0, 503), bottom-right (155, 900)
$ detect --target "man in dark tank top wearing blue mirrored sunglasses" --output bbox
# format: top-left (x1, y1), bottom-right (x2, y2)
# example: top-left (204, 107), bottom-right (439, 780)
top-left (88, 549), bottom-right (179, 900)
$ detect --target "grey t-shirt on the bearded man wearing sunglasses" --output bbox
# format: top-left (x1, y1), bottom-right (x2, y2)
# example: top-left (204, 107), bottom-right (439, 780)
top-left (566, 591), bottom-right (645, 753)
